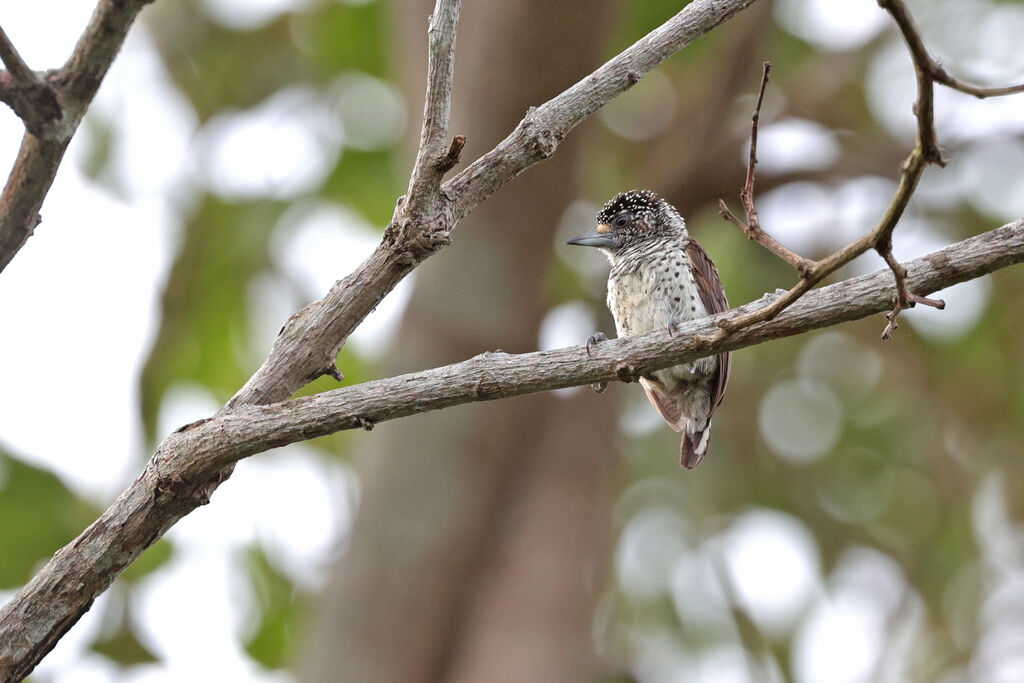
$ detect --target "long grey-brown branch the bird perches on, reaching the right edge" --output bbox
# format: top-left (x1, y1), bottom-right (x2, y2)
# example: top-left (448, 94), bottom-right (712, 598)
top-left (0, 219), bottom-right (1024, 680)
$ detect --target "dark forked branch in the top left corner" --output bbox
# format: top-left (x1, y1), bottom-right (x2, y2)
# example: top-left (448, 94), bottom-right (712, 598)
top-left (0, 0), bottom-right (152, 271)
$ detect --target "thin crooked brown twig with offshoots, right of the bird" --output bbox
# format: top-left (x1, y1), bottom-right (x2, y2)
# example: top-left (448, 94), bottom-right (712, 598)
top-left (719, 0), bottom-right (1024, 339)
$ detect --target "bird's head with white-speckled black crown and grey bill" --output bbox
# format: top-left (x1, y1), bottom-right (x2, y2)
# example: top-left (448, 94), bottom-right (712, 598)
top-left (566, 189), bottom-right (686, 258)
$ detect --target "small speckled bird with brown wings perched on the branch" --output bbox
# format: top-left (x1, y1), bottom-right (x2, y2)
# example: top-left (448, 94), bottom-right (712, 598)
top-left (566, 189), bottom-right (731, 469)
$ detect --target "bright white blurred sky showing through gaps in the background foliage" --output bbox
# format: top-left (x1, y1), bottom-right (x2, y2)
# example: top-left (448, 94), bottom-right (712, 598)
top-left (0, 0), bottom-right (1024, 683)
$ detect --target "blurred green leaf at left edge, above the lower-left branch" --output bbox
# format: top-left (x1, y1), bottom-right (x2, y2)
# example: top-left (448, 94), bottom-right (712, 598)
top-left (0, 453), bottom-right (99, 589)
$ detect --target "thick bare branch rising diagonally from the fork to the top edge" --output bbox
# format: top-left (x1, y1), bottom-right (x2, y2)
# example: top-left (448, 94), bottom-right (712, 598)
top-left (227, 0), bottom-right (756, 408)
